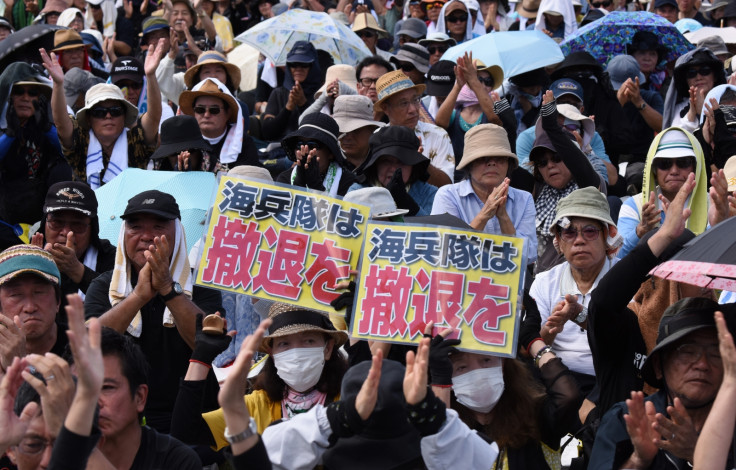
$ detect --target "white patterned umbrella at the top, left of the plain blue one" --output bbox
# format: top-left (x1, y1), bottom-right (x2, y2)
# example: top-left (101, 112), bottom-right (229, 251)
top-left (235, 9), bottom-right (372, 65)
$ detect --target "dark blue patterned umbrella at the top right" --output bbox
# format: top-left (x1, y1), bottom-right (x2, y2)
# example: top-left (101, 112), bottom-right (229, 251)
top-left (560, 11), bottom-right (695, 66)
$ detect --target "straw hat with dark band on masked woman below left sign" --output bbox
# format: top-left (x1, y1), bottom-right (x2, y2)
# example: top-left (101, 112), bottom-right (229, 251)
top-left (261, 302), bottom-right (348, 352)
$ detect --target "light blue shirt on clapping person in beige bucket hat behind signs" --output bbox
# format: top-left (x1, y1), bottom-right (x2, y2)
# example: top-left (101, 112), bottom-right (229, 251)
top-left (432, 179), bottom-right (537, 263)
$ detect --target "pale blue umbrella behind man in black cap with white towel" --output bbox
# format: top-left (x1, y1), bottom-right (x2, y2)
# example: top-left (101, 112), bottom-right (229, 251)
top-left (95, 168), bottom-right (216, 251)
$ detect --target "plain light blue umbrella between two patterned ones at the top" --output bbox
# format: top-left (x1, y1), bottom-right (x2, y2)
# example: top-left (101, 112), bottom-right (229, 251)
top-left (442, 30), bottom-right (565, 78)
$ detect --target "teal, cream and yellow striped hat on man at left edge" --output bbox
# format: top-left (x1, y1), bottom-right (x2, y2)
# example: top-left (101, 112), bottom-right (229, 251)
top-left (0, 245), bottom-right (61, 286)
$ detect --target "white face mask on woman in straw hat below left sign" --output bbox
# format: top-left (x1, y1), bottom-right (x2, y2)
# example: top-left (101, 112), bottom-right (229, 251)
top-left (273, 346), bottom-right (325, 392)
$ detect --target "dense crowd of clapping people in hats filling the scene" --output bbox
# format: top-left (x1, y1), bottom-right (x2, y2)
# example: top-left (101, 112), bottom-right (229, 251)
top-left (0, 0), bottom-right (736, 470)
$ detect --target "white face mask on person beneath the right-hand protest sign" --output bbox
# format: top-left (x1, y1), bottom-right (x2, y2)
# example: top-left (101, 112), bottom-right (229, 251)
top-left (452, 366), bottom-right (504, 413)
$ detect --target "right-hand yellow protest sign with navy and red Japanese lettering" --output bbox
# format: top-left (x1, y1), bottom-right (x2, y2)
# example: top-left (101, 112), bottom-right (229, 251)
top-left (351, 223), bottom-right (526, 357)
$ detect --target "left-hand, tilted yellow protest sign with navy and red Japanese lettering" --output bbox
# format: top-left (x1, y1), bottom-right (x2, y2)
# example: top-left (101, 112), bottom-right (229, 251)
top-left (196, 176), bottom-right (369, 313)
